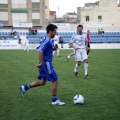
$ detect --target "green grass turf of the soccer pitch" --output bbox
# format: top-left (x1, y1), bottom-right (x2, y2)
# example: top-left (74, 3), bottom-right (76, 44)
top-left (0, 50), bottom-right (120, 120)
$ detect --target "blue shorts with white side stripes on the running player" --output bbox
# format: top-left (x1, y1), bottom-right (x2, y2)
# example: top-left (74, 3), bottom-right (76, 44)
top-left (38, 61), bottom-right (58, 82)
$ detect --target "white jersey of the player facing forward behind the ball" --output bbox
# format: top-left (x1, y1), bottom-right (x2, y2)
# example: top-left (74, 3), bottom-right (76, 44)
top-left (70, 33), bottom-right (87, 48)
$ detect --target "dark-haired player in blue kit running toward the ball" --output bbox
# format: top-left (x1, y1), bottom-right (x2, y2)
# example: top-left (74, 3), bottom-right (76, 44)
top-left (20, 24), bottom-right (65, 105)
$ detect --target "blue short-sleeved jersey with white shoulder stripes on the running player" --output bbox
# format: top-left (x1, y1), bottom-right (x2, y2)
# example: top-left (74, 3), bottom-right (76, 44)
top-left (36, 36), bottom-right (54, 62)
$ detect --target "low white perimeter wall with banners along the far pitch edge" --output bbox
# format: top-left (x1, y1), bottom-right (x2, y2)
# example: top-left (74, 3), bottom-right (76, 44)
top-left (0, 40), bottom-right (120, 50)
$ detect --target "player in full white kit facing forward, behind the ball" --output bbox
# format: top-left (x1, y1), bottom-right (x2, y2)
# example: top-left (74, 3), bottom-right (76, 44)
top-left (70, 25), bottom-right (90, 79)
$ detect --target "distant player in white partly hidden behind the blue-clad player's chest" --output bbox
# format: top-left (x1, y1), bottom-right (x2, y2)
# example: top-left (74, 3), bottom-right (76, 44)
top-left (53, 32), bottom-right (60, 57)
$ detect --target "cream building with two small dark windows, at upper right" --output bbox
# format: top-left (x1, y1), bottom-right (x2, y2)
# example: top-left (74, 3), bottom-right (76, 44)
top-left (77, 0), bottom-right (120, 29)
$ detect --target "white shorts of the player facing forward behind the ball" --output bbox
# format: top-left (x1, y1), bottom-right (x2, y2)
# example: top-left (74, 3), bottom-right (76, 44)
top-left (75, 48), bottom-right (88, 61)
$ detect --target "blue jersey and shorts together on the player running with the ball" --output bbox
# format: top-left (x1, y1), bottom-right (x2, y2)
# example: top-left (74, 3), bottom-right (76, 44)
top-left (36, 36), bottom-right (58, 82)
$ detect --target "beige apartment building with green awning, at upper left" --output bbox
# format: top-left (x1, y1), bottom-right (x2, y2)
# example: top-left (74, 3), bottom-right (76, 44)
top-left (0, 0), bottom-right (49, 27)
